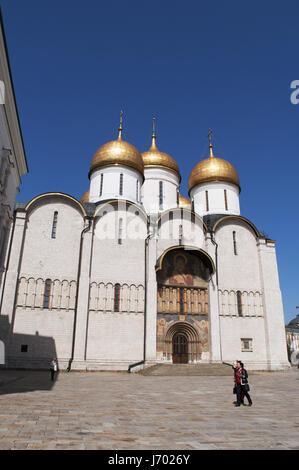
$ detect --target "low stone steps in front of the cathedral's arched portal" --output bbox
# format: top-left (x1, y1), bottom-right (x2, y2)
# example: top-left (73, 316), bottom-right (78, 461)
top-left (138, 363), bottom-right (233, 376)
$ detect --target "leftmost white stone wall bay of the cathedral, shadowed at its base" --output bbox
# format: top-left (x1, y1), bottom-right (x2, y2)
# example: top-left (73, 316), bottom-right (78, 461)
top-left (1, 196), bottom-right (83, 367)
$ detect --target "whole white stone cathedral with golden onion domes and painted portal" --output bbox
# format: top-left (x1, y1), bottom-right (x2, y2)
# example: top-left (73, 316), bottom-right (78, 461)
top-left (0, 117), bottom-right (289, 370)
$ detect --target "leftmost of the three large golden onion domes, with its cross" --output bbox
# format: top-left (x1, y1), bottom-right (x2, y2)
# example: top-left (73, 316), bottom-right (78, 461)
top-left (89, 114), bottom-right (144, 176)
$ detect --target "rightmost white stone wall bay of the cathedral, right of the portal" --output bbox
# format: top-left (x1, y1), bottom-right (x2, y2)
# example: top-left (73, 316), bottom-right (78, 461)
top-left (215, 219), bottom-right (288, 370)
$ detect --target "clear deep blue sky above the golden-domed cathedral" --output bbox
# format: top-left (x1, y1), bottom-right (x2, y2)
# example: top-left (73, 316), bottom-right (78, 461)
top-left (0, 0), bottom-right (299, 322)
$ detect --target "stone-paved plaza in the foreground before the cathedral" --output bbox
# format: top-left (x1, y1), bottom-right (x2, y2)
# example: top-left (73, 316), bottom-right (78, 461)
top-left (0, 368), bottom-right (299, 450)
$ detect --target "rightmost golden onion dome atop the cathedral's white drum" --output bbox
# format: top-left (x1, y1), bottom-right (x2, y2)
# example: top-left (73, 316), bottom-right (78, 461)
top-left (189, 144), bottom-right (240, 191)
